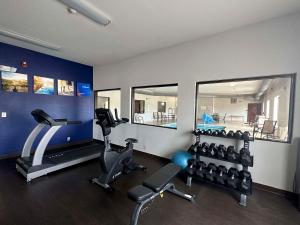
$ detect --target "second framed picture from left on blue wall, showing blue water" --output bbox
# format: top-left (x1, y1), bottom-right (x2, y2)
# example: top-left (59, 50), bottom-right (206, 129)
top-left (33, 76), bottom-right (54, 95)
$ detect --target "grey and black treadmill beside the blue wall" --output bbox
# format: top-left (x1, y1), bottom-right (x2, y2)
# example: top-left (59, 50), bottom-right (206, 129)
top-left (16, 109), bottom-right (104, 182)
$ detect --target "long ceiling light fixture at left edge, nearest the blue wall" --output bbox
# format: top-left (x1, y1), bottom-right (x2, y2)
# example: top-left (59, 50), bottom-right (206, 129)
top-left (0, 28), bottom-right (61, 51)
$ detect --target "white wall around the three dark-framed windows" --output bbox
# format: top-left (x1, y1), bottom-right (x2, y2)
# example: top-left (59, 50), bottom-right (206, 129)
top-left (94, 14), bottom-right (300, 190)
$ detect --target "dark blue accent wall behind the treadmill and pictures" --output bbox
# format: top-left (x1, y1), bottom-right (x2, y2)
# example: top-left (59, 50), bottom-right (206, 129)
top-left (0, 42), bottom-right (94, 157)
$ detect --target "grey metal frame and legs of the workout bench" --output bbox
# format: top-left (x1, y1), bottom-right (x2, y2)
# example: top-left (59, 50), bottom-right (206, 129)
top-left (130, 183), bottom-right (195, 225)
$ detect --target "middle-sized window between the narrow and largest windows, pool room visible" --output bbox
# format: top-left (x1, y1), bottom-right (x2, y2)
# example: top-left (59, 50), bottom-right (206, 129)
top-left (132, 84), bottom-right (178, 129)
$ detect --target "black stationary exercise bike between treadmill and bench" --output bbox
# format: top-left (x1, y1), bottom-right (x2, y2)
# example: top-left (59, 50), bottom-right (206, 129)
top-left (91, 108), bottom-right (146, 190)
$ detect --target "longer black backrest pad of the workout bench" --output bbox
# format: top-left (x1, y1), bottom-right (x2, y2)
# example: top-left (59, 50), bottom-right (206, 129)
top-left (143, 163), bottom-right (181, 192)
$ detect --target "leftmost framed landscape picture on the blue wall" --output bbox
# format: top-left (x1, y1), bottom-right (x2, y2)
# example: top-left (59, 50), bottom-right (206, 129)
top-left (1, 72), bottom-right (28, 92)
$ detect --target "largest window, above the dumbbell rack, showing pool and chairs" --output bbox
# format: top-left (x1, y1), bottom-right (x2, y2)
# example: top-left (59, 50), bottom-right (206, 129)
top-left (196, 75), bottom-right (295, 142)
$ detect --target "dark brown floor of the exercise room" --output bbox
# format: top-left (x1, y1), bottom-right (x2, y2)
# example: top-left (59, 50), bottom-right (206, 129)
top-left (0, 153), bottom-right (300, 225)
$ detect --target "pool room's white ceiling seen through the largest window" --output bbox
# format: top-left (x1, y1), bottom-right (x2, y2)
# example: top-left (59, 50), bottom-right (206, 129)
top-left (198, 80), bottom-right (264, 96)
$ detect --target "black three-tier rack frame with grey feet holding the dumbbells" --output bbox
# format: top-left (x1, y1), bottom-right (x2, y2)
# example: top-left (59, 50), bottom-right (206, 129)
top-left (186, 132), bottom-right (254, 206)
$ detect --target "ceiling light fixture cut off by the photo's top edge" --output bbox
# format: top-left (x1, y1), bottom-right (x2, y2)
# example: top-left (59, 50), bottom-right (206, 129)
top-left (58, 0), bottom-right (111, 26)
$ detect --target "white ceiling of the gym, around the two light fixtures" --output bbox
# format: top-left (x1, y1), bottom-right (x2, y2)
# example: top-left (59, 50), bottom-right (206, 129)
top-left (0, 0), bottom-right (300, 65)
